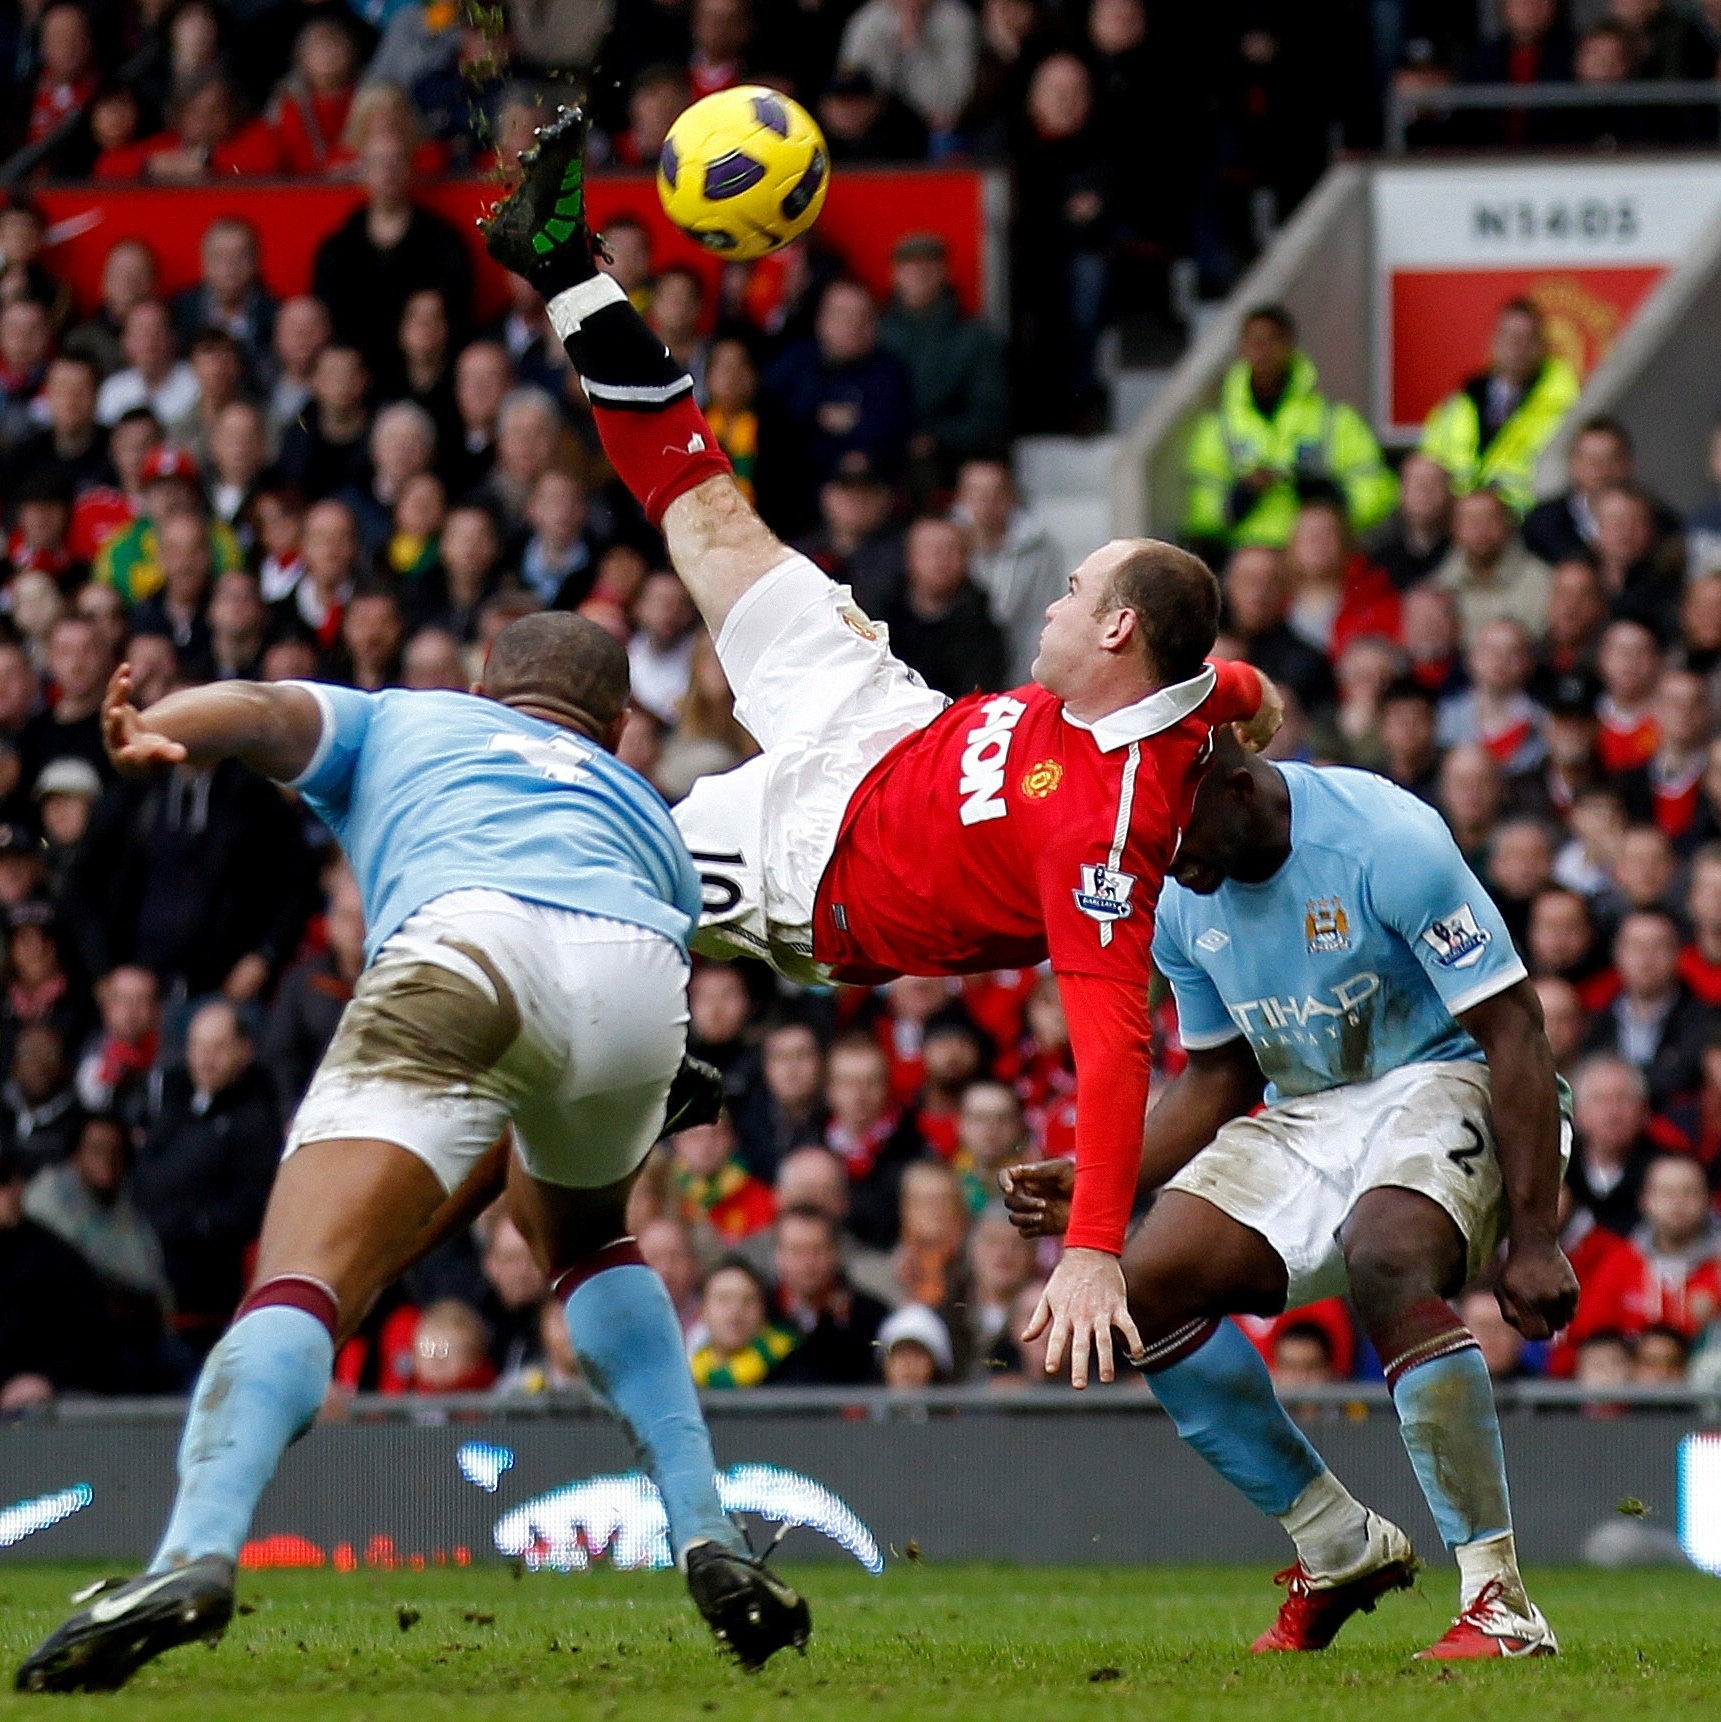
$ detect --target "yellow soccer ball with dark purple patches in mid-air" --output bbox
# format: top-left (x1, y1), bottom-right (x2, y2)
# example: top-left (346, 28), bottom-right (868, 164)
top-left (658, 84), bottom-right (830, 258)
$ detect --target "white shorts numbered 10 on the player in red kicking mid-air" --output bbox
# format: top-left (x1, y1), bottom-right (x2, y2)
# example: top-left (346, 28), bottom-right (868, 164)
top-left (675, 556), bottom-right (949, 982)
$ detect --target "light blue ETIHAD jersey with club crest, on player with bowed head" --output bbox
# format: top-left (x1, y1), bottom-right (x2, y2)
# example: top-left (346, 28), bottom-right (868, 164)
top-left (1153, 765), bottom-right (1525, 1106)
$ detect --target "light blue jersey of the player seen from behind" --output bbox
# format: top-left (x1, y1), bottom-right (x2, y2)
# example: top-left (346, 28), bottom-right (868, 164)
top-left (293, 682), bottom-right (699, 957)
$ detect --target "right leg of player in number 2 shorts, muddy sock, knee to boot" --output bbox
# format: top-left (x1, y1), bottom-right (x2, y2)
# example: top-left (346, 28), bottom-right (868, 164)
top-left (1340, 1188), bottom-right (1559, 1660)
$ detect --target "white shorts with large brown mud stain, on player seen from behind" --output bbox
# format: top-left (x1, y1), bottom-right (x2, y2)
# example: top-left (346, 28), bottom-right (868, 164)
top-left (286, 890), bottom-right (687, 1192)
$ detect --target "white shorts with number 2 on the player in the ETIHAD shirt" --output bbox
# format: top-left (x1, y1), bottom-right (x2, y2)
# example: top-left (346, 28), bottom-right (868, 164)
top-left (1166, 1062), bottom-right (1571, 1309)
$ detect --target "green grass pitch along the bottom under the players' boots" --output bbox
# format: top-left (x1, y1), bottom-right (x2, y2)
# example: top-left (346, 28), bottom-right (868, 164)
top-left (0, 1564), bottom-right (1721, 1722)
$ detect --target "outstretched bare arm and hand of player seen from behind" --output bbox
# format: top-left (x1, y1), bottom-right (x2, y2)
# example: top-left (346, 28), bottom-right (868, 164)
top-left (102, 663), bottom-right (322, 784)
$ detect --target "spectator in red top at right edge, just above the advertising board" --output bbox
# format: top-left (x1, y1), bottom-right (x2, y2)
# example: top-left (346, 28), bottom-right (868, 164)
top-left (1568, 1154), bottom-right (1721, 1345)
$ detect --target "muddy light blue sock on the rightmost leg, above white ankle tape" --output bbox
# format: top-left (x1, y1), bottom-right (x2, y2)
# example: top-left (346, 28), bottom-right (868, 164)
top-left (1392, 1345), bottom-right (1513, 1548)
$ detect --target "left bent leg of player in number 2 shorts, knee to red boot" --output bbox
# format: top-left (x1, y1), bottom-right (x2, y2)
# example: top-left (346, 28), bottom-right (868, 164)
top-left (1123, 1190), bottom-right (1416, 1651)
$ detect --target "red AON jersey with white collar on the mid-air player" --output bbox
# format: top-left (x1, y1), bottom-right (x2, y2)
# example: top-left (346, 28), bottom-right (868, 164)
top-left (813, 663), bottom-right (1261, 983)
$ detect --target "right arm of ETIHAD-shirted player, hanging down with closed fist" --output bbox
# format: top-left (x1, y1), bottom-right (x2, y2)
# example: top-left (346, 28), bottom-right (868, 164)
top-left (1459, 980), bottom-right (1578, 1340)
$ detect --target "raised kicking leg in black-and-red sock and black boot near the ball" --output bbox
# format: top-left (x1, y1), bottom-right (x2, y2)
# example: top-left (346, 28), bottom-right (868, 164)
top-left (484, 108), bottom-right (792, 634)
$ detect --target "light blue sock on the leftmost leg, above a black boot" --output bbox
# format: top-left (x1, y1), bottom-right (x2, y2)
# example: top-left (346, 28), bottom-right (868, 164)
top-left (150, 1304), bottom-right (334, 1572)
